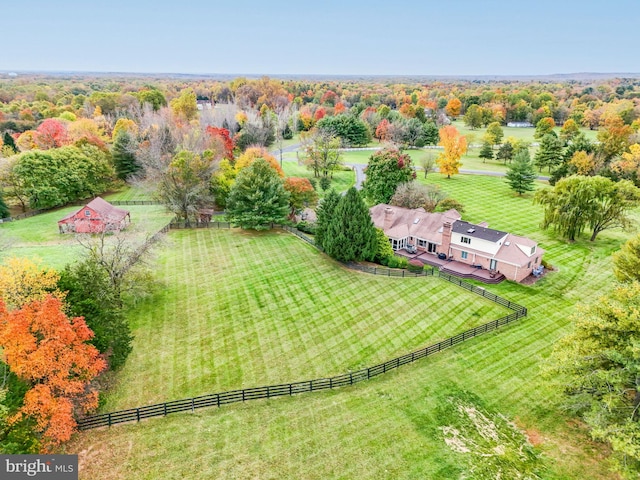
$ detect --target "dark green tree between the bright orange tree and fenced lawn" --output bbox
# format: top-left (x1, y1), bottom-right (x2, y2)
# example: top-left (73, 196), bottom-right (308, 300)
top-left (58, 260), bottom-right (133, 369)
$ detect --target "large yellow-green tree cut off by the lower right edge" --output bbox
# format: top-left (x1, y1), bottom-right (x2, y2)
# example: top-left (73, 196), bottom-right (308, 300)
top-left (549, 281), bottom-right (640, 478)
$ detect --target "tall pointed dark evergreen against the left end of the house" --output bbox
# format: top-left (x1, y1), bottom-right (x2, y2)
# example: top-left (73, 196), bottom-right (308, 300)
top-left (324, 187), bottom-right (378, 262)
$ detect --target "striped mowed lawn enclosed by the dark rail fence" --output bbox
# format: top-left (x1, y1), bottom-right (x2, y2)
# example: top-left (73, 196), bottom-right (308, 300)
top-left (105, 230), bottom-right (509, 410)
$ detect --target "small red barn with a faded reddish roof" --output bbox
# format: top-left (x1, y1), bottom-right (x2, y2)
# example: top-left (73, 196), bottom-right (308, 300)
top-left (58, 197), bottom-right (131, 233)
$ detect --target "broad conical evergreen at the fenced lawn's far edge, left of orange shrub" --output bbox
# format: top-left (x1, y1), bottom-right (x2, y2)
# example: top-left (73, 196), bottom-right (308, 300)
top-left (227, 158), bottom-right (289, 230)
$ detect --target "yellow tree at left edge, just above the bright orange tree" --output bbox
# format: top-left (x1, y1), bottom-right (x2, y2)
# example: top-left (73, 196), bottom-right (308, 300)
top-left (0, 258), bottom-right (64, 308)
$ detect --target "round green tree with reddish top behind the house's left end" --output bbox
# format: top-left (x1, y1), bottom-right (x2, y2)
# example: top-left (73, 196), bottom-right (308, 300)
top-left (363, 148), bottom-right (415, 203)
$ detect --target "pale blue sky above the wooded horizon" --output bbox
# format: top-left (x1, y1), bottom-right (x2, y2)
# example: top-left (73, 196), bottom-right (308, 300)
top-left (0, 0), bottom-right (640, 75)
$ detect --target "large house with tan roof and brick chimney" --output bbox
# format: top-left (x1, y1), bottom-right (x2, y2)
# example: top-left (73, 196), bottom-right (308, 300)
top-left (370, 204), bottom-right (544, 282)
